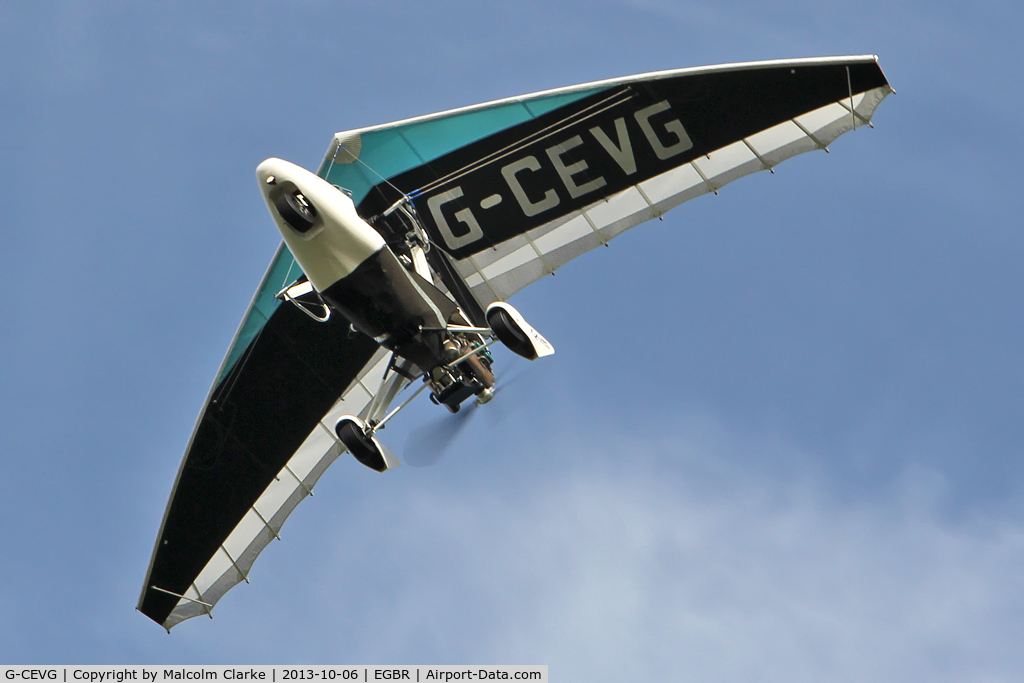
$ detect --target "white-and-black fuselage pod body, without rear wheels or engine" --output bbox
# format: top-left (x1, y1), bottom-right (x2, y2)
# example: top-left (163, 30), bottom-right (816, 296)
top-left (256, 159), bottom-right (466, 371)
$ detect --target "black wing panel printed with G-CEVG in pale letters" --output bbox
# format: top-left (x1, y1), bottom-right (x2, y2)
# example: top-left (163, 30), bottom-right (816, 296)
top-left (358, 60), bottom-right (888, 259)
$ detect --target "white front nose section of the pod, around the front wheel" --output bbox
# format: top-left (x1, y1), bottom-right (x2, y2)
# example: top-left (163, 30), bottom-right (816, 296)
top-left (256, 159), bottom-right (384, 292)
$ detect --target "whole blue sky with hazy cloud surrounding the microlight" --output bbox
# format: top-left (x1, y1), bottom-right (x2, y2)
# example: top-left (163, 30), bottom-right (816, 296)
top-left (0, 0), bottom-right (1024, 681)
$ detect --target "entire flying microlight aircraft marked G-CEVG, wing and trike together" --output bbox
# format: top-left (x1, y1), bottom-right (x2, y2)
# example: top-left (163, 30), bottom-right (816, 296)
top-left (138, 55), bottom-right (892, 631)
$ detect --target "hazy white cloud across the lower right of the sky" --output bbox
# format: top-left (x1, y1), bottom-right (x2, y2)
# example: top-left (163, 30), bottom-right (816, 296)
top-left (276, 423), bottom-right (1024, 681)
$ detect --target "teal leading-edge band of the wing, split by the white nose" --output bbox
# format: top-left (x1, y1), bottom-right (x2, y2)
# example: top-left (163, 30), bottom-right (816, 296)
top-left (214, 87), bottom-right (604, 386)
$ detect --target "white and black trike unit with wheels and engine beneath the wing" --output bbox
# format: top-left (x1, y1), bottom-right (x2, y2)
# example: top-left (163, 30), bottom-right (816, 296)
top-left (264, 159), bottom-right (554, 472)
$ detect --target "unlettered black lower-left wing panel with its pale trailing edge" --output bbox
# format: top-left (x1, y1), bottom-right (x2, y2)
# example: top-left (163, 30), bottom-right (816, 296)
top-left (138, 270), bottom-right (379, 630)
